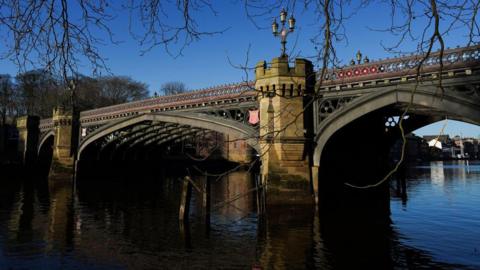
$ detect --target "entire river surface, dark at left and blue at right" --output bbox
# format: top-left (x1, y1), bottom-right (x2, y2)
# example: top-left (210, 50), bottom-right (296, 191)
top-left (0, 161), bottom-right (480, 269)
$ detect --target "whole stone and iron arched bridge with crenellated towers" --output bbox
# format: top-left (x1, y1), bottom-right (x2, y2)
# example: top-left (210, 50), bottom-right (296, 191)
top-left (18, 46), bottom-right (480, 205)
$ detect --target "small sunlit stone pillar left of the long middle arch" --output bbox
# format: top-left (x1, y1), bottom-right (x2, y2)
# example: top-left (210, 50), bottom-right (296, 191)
top-left (50, 107), bottom-right (74, 177)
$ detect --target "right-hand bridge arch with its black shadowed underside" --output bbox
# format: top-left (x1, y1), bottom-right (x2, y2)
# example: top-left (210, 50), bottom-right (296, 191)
top-left (314, 87), bottom-right (480, 212)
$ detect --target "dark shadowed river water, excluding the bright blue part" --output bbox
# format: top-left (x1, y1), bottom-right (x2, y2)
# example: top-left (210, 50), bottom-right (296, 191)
top-left (0, 160), bottom-right (478, 269)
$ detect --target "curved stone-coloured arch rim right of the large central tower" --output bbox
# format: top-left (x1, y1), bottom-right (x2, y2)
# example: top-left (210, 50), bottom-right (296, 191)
top-left (313, 84), bottom-right (480, 166)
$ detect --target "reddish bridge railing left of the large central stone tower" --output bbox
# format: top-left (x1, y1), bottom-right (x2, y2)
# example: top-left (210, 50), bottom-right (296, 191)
top-left (80, 82), bottom-right (257, 123)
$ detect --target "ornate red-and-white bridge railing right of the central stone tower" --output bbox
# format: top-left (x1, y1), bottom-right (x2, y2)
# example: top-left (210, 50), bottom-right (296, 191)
top-left (317, 45), bottom-right (480, 91)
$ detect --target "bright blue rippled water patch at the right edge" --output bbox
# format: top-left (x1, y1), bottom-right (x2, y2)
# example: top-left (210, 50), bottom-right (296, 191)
top-left (391, 161), bottom-right (480, 268)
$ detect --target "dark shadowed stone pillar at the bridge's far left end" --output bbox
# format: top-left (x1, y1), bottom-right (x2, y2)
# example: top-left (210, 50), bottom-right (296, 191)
top-left (17, 115), bottom-right (40, 166)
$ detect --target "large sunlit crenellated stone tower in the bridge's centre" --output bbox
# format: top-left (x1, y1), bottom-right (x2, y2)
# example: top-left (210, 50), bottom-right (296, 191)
top-left (255, 57), bottom-right (314, 205)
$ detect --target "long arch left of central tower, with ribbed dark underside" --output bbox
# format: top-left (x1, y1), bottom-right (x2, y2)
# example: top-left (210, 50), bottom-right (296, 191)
top-left (78, 113), bottom-right (257, 180)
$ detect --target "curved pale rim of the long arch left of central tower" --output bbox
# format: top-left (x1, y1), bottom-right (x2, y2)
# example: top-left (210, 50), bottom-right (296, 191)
top-left (78, 112), bottom-right (259, 159)
